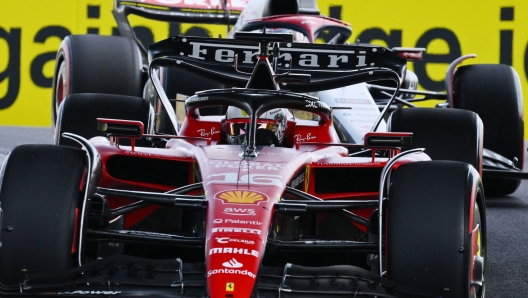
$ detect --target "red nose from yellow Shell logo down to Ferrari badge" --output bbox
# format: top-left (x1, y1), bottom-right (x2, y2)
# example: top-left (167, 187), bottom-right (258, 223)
top-left (205, 186), bottom-right (278, 298)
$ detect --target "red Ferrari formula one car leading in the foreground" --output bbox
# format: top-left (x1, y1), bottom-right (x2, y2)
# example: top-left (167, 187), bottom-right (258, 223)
top-left (0, 32), bottom-right (486, 298)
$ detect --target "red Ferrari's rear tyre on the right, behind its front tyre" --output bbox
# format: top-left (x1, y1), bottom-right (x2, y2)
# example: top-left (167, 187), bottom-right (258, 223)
top-left (387, 108), bottom-right (483, 173)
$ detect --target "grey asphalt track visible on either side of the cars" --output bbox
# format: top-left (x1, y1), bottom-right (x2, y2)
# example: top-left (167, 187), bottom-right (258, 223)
top-left (0, 126), bottom-right (528, 298)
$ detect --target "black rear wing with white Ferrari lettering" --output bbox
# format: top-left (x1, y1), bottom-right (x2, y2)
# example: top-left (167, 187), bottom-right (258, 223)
top-left (149, 36), bottom-right (407, 92)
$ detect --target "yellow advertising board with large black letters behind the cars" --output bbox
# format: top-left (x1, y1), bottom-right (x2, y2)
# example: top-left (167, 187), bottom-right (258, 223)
top-left (0, 0), bottom-right (528, 131)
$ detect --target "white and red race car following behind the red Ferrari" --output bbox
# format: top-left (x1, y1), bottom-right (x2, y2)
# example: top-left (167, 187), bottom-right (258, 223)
top-left (52, 0), bottom-right (528, 200)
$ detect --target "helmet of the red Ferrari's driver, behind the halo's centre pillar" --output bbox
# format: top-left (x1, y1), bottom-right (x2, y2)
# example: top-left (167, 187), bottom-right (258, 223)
top-left (226, 106), bottom-right (293, 147)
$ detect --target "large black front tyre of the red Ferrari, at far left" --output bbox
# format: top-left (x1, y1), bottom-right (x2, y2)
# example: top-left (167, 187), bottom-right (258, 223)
top-left (0, 145), bottom-right (86, 289)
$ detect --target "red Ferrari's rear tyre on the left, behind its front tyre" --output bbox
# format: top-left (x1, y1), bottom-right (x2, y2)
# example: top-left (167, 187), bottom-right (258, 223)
top-left (54, 93), bottom-right (154, 148)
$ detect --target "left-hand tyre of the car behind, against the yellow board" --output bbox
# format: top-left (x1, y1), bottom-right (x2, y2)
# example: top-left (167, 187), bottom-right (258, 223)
top-left (52, 34), bottom-right (144, 125)
